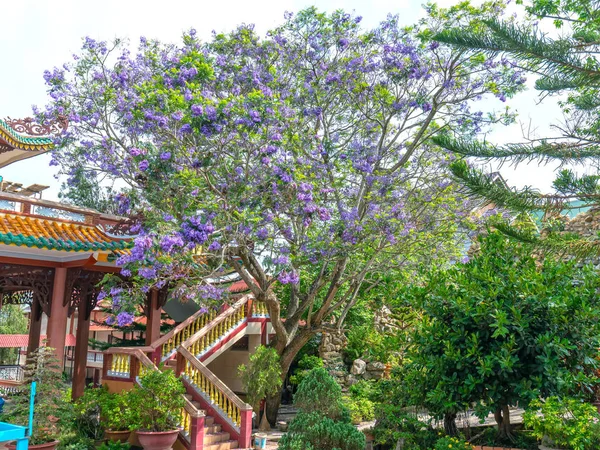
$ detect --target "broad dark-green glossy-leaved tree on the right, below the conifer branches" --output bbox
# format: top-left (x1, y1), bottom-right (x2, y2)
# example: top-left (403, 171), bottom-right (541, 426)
top-left (405, 232), bottom-right (600, 437)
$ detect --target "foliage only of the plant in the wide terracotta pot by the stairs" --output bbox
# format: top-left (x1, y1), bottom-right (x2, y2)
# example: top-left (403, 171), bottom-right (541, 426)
top-left (128, 370), bottom-right (185, 432)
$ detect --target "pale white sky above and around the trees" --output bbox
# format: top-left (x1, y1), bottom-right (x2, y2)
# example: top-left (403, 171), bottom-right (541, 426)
top-left (0, 0), bottom-right (560, 199)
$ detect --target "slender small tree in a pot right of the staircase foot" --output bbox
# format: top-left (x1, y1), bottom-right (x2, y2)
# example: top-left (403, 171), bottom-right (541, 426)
top-left (238, 345), bottom-right (283, 431)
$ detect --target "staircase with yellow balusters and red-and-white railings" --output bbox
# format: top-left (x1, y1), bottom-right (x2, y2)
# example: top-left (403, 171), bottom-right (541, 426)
top-left (103, 295), bottom-right (269, 450)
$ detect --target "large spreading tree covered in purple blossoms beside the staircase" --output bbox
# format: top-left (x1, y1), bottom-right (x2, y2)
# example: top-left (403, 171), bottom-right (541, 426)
top-left (39, 2), bottom-right (523, 422)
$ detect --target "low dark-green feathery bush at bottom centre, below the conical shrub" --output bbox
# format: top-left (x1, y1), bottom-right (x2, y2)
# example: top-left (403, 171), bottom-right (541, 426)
top-left (279, 412), bottom-right (365, 450)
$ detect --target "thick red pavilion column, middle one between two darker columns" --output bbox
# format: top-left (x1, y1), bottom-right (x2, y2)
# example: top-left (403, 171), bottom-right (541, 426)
top-left (46, 267), bottom-right (69, 368)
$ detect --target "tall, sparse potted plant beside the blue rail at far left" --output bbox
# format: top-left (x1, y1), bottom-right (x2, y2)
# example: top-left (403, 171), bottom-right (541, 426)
top-left (5, 347), bottom-right (69, 450)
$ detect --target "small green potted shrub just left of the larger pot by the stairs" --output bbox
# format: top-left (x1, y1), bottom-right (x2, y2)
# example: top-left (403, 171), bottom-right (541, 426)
top-left (97, 387), bottom-right (131, 442)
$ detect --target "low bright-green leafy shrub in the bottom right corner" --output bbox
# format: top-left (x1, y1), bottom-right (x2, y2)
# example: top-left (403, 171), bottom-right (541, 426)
top-left (523, 397), bottom-right (600, 450)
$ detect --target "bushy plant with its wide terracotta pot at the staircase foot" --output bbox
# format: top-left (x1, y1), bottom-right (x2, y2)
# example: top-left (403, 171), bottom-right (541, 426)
top-left (129, 370), bottom-right (185, 450)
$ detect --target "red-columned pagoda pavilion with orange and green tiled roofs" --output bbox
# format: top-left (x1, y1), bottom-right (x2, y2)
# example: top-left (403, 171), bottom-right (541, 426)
top-left (0, 119), bottom-right (138, 397)
